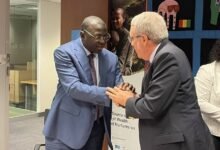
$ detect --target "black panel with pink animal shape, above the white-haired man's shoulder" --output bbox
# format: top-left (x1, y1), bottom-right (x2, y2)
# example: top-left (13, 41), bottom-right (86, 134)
top-left (152, 0), bottom-right (195, 31)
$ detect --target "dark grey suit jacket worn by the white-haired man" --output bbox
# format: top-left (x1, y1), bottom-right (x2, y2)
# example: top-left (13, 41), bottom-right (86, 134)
top-left (126, 40), bottom-right (214, 150)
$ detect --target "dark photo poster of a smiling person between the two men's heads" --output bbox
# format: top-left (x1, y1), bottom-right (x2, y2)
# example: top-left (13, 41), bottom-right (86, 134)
top-left (108, 0), bottom-right (146, 76)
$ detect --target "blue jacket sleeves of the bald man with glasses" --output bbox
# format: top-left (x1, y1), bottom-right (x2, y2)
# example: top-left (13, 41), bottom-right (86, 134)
top-left (54, 49), bottom-right (122, 107)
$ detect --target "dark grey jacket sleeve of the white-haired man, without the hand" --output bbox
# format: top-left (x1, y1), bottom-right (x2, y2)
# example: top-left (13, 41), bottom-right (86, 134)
top-left (125, 53), bottom-right (182, 119)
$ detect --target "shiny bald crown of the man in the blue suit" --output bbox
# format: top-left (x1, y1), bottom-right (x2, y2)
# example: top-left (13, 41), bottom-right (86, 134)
top-left (81, 16), bottom-right (106, 30)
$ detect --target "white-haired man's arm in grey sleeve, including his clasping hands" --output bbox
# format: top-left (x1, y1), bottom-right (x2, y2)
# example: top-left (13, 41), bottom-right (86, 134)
top-left (106, 52), bottom-right (180, 119)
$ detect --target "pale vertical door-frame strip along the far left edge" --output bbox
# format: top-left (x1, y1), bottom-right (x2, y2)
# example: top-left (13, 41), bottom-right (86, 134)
top-left (0, 0), bottom-right (9, 150)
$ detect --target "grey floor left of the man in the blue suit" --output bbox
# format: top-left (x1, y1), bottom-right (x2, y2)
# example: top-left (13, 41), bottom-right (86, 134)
top-left (9, 115), bottom-right (44, 150)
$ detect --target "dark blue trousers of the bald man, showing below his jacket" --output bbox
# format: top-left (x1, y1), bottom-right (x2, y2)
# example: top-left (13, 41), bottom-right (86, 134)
top-left (46, 117), bottom-right (105, 150)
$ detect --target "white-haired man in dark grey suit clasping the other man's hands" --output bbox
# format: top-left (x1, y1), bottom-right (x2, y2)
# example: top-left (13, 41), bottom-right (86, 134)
top-left (106, 12), bottom-right (214, 150)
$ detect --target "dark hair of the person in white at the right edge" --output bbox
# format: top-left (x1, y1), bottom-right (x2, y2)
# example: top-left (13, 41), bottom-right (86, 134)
top-left (210, 39), bottom-right (220, 61)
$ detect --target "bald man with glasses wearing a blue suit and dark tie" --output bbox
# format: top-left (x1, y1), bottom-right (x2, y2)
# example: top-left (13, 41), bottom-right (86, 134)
top-left (44, 16), bottom-right (122, 150)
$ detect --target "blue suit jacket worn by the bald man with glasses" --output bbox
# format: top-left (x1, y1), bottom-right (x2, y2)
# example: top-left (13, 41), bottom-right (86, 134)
top-left (44, 39), bottom-right (122, 149)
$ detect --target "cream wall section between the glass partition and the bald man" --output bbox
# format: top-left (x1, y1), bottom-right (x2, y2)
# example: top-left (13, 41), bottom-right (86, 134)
top-left (37, 0), bottom-right (61, 112)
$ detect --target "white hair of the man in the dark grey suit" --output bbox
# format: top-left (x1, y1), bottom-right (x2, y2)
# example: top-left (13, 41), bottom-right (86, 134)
top-left (131, 11), bottom-right (168, 43)
